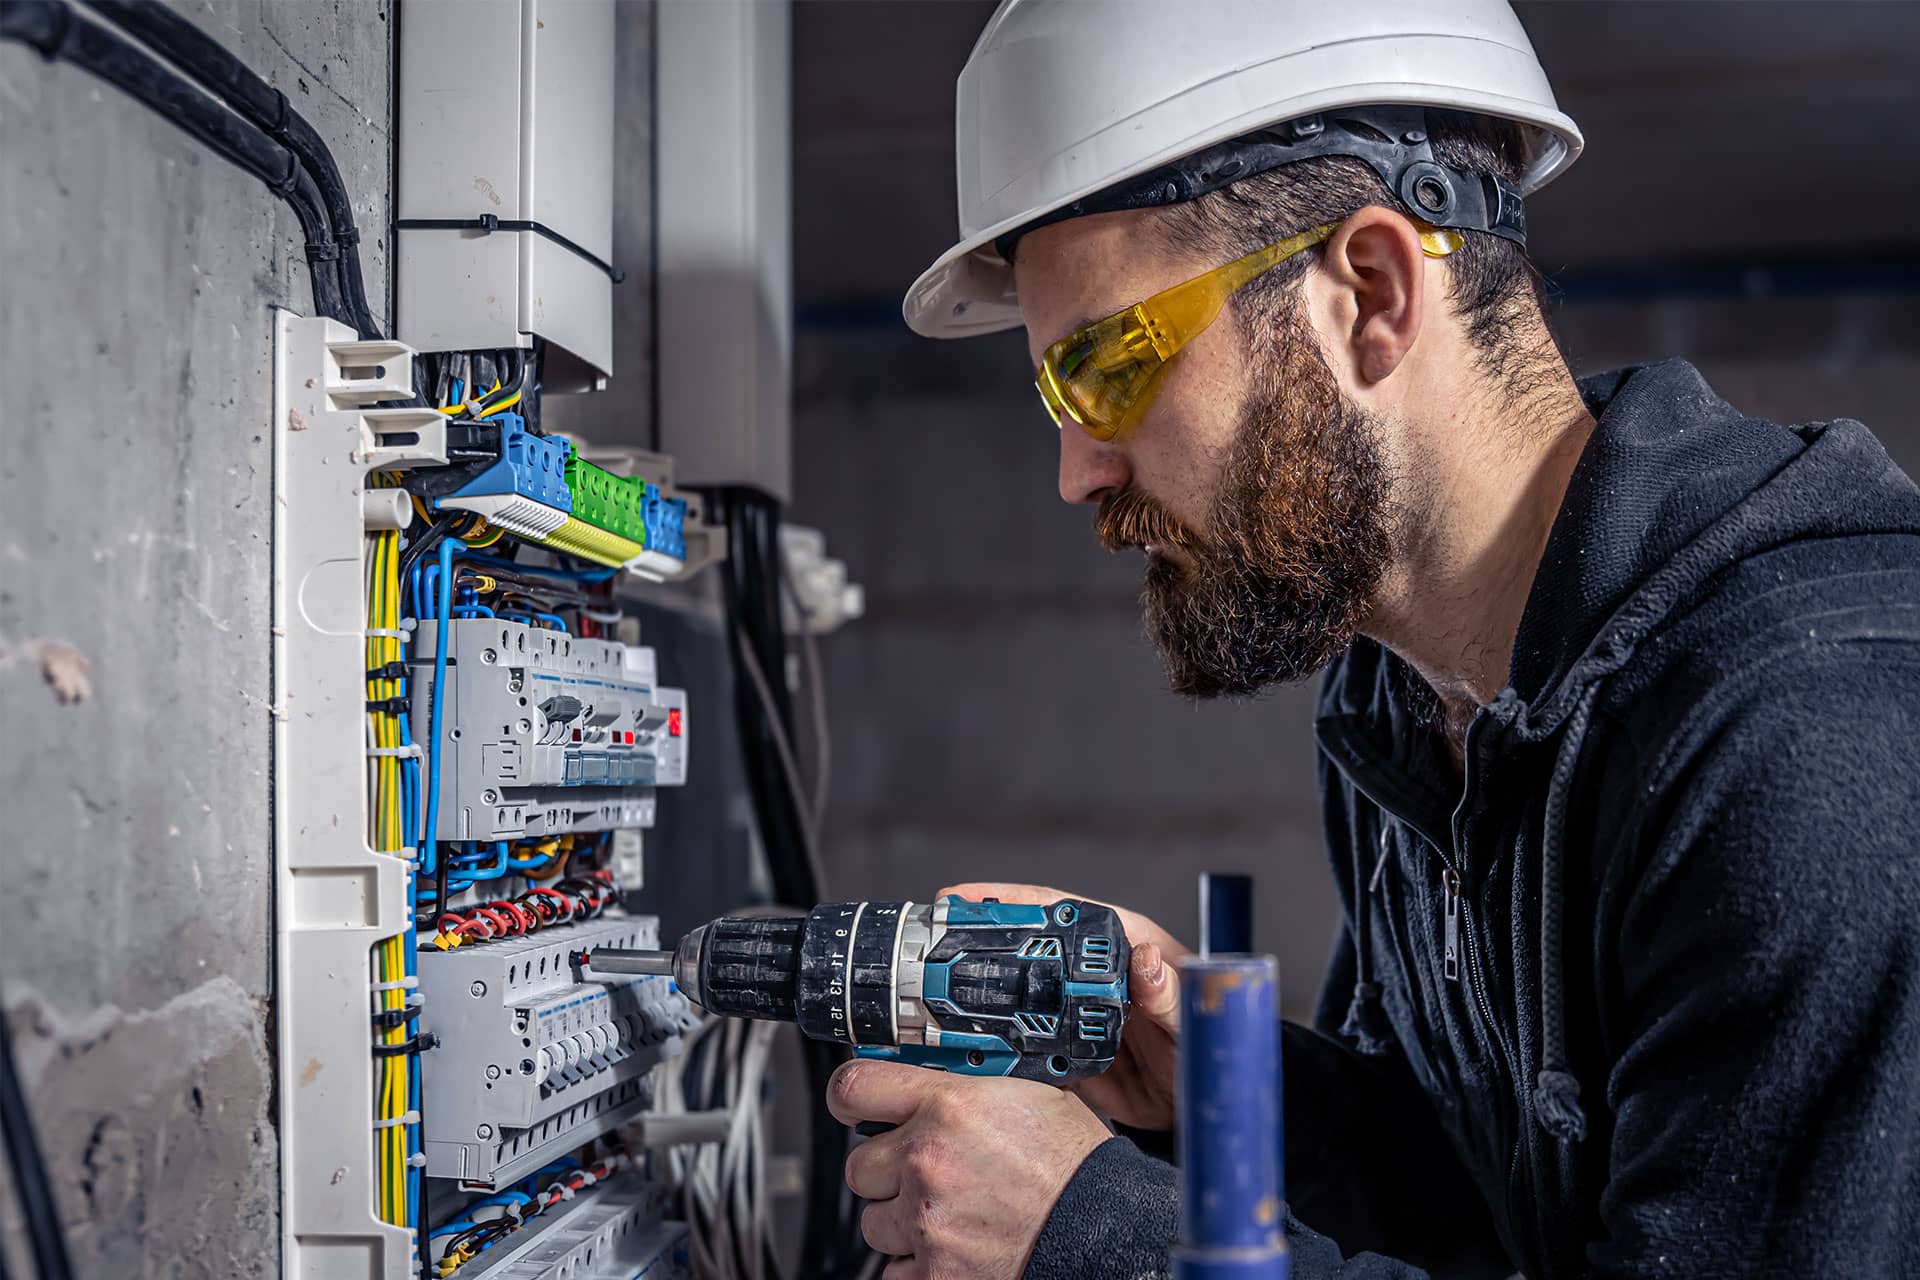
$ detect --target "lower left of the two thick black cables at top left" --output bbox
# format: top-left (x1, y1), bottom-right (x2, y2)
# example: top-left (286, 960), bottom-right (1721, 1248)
top-left (0, 0), bottom-right (355, 324)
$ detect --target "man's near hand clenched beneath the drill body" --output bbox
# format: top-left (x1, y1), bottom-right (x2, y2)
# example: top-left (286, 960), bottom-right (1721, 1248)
top-left (828, 1061), bottom-right (1112, 1280)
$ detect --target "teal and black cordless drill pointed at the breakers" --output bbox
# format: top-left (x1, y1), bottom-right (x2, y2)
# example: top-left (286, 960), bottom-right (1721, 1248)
top-left (580, 894), bottom-right (1133, 1084)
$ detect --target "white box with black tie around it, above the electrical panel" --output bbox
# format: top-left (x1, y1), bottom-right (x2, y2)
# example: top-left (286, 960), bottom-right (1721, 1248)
top-left (394, 0), bottom-right (614, 391)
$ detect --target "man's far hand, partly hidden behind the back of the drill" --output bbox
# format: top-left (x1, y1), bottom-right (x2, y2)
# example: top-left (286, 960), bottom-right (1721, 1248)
top-left (939, 881), bottom-right (1188, 1128)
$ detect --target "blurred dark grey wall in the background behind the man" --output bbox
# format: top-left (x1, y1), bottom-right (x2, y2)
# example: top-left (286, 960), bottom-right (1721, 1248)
top-left (795, 294), bottom-right (1920, 1017)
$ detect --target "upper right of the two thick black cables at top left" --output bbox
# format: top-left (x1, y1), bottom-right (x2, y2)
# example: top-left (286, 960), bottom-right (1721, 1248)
top-left (88, 0), bottom-right (380, 338)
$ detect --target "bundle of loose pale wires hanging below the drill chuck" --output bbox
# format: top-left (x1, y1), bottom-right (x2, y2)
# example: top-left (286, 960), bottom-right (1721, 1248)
top-left (655, 1017), bottom-right (779, 1280)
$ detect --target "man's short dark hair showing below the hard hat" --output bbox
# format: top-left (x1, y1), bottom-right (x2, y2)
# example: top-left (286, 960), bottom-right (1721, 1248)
top-left (1158, 109), bottom-right (1563, 395)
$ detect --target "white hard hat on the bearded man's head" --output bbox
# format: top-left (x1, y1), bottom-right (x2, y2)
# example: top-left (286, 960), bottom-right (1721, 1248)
top-left (902, 0), bottom-right (1582, 338)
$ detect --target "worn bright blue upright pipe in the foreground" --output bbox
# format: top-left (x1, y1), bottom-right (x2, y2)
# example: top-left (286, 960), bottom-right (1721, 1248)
top-left (1173, 956), bottom-right (1286, 1280)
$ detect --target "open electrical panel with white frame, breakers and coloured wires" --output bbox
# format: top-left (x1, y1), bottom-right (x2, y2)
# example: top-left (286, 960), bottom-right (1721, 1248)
top-left (273, 313), bottom-right (706, 1280)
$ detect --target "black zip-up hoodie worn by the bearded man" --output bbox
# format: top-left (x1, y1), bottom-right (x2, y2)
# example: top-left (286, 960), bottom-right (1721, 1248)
top-left (1027, 361), bottom-right (1920, 1280)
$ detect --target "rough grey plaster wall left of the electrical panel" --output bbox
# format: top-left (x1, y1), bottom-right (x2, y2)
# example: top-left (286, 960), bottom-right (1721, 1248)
top-left (0, 0), bottom-right (392, 1276)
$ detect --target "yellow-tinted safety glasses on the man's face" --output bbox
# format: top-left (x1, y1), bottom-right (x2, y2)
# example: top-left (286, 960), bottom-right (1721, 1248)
top-left (1033, 223), bottom-right (1463, 439)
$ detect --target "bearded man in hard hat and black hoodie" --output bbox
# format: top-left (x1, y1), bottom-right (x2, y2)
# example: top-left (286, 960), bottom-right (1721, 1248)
top-left (829, 0), bottom-right (1920, 1280)
